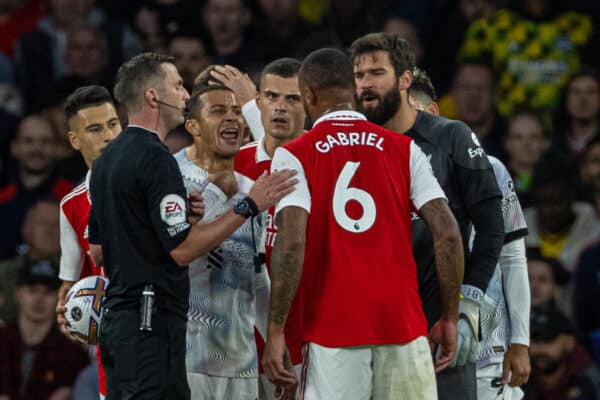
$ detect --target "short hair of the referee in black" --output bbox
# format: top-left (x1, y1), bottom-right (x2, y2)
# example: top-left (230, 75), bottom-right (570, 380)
top-left (114, 53), bottom-right (174, 112)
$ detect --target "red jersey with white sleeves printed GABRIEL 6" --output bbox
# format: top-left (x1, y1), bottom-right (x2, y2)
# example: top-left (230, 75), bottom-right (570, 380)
top-left (272, 111), bottom-right (445, 347)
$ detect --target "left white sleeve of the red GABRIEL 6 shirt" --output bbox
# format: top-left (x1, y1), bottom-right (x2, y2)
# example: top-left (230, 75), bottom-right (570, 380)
top-left (271, 147), bottom-right (311, 214)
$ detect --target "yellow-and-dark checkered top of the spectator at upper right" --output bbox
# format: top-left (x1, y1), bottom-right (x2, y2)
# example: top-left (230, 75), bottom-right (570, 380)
top-left (459, 0), bottom-right (594, 123)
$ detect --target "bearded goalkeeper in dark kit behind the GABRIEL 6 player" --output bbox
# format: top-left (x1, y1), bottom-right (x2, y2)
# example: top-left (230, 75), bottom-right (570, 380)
top-left (350, 33), bottom-right (504, 400)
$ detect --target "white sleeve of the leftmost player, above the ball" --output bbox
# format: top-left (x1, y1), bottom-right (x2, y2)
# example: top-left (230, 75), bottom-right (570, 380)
top-left (58, 207), bottom-right (84, 282)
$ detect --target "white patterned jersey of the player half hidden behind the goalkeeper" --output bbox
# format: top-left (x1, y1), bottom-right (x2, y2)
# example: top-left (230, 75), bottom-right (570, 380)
top-left (471, 156), bottom-right (527, 367)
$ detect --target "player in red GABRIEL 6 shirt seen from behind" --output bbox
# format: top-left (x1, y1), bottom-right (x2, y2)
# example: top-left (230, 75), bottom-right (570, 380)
top-left (263, 49), bottom-right (464, 400)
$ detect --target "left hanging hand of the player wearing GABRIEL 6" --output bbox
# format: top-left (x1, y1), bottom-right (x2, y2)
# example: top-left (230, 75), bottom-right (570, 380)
top-left (262, 333), bottom-right (298, 391)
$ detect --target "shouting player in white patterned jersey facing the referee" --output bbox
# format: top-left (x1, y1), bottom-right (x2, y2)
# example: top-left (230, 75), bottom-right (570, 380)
top-left (175, 85), bottom-right (270, 399)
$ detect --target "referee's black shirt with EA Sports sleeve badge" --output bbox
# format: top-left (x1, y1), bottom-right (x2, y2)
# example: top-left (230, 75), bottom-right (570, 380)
top-left (89, 126), bottom-right (190, 318)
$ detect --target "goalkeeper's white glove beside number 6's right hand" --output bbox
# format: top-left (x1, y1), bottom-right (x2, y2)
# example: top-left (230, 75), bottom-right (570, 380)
top-left (450, 285), bottom-right (483, 368)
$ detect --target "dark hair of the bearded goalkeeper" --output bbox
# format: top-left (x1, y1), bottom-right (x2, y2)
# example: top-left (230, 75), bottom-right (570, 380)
top-left (350, 32), bottom-right (416, 76)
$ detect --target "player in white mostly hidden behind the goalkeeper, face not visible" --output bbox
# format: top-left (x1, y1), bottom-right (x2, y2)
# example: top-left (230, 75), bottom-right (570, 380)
top-left (410, 68), bottom-right (531, 400)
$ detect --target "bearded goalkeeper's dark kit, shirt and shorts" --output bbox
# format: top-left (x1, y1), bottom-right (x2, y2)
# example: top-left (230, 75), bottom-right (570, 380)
top-left (406, 112), bottom-right (504, 399)
